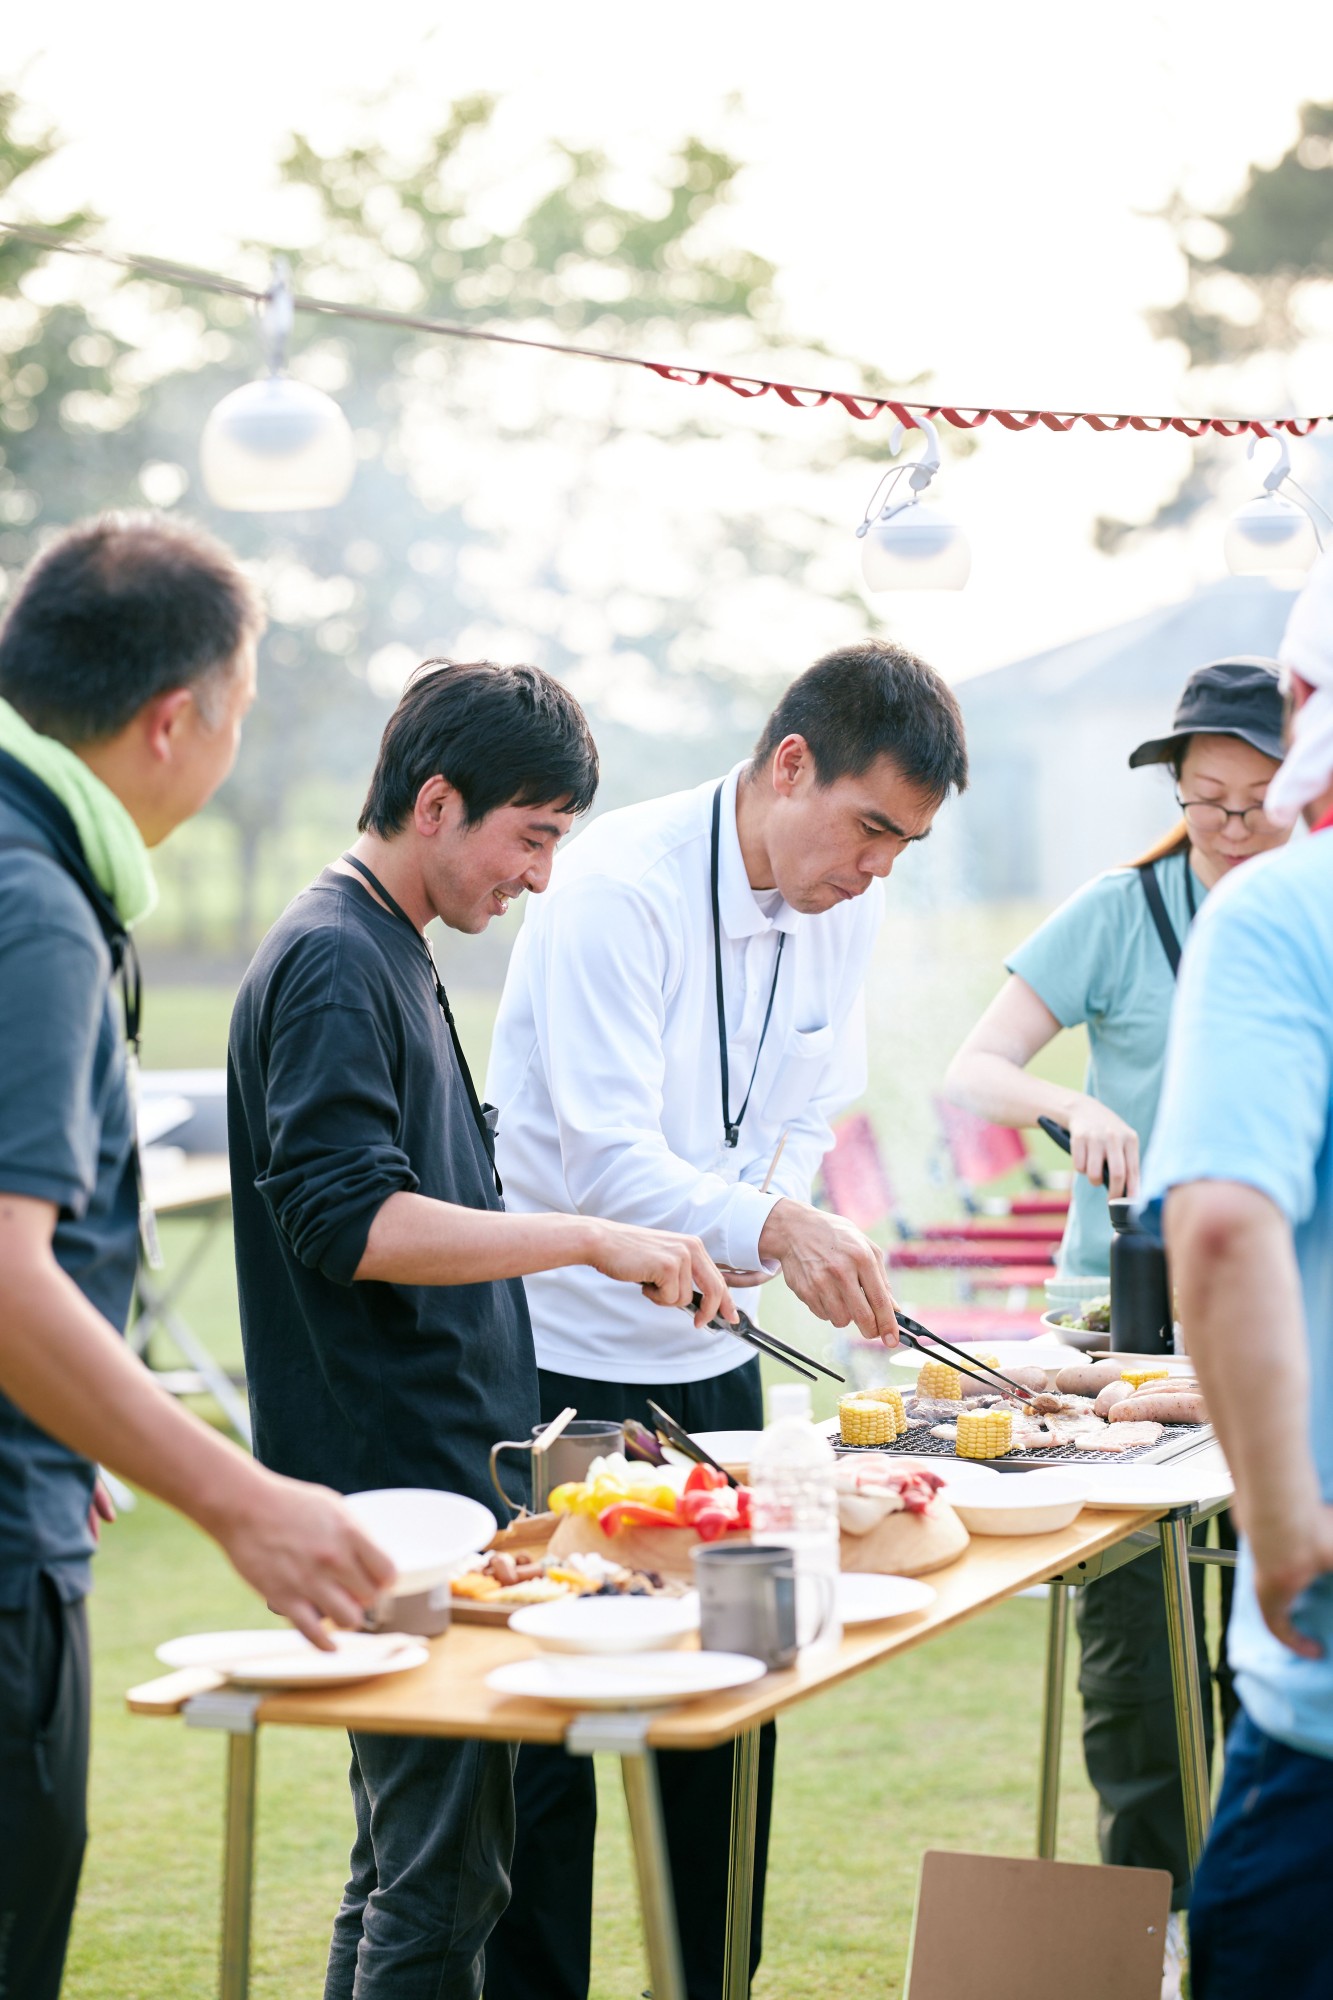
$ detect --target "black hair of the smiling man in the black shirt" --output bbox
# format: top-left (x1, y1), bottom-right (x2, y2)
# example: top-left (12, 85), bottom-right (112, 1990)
top-left (356, 660), bottom-right (598, 840)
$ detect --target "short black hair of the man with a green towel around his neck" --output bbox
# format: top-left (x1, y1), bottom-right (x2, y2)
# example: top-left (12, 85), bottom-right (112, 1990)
top-left (0, 514), bottom-right (264, 744)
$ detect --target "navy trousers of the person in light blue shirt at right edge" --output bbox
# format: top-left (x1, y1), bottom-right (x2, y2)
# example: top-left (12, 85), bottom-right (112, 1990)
top-left (1189, 1712), bottom-right (1333, 2000)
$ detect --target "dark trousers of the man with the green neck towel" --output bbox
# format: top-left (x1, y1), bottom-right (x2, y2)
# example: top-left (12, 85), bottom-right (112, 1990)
top-left (0, 1576), bottom-right (88, 2000)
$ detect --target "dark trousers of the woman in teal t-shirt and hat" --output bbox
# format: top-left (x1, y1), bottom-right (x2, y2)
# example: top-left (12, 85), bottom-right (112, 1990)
top-left (1075, 1516), bottom-right (1235, 1910)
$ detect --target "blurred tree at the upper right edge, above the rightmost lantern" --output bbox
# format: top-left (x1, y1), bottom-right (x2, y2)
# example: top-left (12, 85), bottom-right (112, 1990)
top-left (1095, 104), bottom-right (1333, 552)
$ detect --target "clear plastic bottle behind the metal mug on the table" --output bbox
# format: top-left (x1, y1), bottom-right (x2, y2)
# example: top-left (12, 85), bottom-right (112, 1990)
top-left (751, 1382), bottom-right (843, 1658)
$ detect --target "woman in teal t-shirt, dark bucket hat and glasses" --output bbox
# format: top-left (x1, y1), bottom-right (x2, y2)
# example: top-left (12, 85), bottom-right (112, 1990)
top-left (945, 658), bottom-right (1287, 1992)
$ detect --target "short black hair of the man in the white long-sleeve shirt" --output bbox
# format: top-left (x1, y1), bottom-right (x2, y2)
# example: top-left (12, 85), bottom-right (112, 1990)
top-left (753, 638), bottom-right (967, 800)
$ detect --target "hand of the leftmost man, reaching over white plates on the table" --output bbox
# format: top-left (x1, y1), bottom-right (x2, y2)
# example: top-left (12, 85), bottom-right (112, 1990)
top-left (208, 1466), bottom-right (394, 1652)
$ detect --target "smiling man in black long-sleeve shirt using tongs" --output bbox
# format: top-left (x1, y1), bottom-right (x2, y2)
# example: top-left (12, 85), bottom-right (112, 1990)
top-left (228, 664), bottom-right (731, 2000)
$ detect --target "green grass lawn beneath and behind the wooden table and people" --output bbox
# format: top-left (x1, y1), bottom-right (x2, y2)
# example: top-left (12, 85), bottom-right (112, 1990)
top-left (66, 910), bottom-right (1095, 2000)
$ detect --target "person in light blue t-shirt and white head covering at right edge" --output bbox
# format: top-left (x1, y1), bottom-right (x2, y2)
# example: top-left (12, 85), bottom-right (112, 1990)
top-left (1145, 556), bottom-right (1333, 2000)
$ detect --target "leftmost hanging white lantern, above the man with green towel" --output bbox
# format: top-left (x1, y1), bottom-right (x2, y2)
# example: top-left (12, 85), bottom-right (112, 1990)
top-left (200, 258), bottom-right (356, 514)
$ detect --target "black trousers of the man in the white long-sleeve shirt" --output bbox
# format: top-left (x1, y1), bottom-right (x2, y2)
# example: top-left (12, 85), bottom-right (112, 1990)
top-left (486, 1360), bottom-right (777, 2000)
